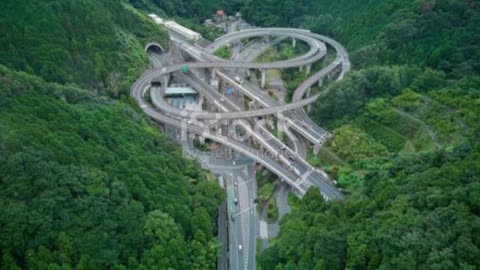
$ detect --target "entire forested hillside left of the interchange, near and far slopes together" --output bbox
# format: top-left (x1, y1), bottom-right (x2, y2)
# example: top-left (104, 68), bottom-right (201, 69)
top-left (0, 0), bottom-right (223, 270)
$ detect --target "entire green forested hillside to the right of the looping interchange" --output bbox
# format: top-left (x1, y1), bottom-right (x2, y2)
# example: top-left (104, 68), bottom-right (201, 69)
top-left (255, 0), bottom-right (480, 269)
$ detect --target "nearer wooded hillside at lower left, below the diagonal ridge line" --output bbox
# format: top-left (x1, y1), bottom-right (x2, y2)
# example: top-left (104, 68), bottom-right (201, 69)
top-left (0, 67), bottom-right (222, 269)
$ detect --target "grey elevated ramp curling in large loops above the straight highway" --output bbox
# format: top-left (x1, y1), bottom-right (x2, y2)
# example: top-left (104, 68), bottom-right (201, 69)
top-left (132, 28), bottom-right (350, 199)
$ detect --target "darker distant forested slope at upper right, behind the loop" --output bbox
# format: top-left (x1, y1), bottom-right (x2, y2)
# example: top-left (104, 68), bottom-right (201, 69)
top-left (242, 0), bottom-right (480, 78)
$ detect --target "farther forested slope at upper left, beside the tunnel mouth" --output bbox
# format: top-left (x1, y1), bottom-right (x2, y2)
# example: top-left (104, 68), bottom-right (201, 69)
top-left (0, 0), bottom-right (167, 97)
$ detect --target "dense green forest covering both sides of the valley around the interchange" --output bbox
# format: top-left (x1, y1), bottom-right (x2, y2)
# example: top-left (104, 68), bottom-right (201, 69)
top-left (0, 0), bottom-right (480, 270)
